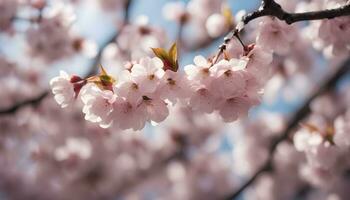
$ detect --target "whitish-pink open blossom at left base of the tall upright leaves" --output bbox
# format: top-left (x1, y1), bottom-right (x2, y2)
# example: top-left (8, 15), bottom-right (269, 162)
top-left (131, 57), bottom-right (164, 93)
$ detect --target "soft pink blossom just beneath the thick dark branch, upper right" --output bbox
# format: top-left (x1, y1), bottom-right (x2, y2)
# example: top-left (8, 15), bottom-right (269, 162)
top-left (256, 17), bottom-right (296, 55)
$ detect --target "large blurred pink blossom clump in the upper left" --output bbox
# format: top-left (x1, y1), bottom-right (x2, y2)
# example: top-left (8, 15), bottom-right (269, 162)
top-left (26, 4), bottom-right (96, 63)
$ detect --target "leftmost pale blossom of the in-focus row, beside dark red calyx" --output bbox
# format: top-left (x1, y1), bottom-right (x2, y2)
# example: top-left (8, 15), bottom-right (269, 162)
top-left (50, 71), bottom-right (75, 108)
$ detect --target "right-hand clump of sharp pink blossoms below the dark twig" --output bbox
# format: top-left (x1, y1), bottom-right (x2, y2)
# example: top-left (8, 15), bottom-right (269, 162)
top-left (185, 56), bottom-right (260, 122)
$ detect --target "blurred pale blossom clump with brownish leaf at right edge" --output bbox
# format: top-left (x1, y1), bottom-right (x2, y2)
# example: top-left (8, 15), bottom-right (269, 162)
top-left (293, 91), bottom-right (350, 188)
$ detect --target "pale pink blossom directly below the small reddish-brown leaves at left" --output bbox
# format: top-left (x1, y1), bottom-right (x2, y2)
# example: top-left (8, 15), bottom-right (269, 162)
top-left (81, 84), bottom-right (116, 128)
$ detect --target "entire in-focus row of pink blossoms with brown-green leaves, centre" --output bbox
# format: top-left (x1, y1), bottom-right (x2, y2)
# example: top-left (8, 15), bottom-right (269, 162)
top-left (50, 39), bottom-right (271, 130)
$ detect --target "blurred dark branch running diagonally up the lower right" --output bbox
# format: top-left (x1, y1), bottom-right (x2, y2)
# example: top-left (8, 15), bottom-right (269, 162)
top-left (224, 59), bottom-right (350, 200)
